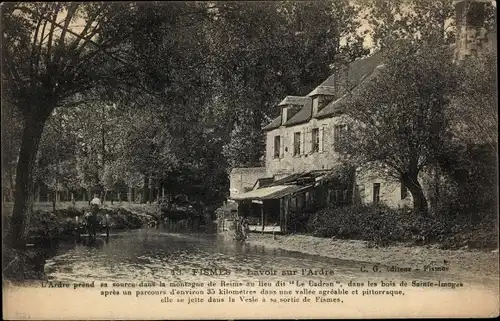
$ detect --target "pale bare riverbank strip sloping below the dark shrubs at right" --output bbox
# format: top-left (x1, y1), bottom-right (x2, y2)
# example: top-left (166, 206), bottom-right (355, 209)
top-left (247, 233), bottom-right (499, 278)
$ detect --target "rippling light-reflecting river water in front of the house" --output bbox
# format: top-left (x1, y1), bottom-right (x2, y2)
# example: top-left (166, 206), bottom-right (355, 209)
top-left (45, 229), bottom-right (496, 288)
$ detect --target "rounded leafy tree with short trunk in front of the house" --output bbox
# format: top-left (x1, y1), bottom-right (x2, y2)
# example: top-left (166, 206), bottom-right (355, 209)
top-left (345, 40), bottom-right (458, 211)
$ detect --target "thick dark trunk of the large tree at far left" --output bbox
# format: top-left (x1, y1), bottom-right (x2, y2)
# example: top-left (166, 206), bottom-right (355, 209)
top-left (7, 115), bottom-right (46, 248)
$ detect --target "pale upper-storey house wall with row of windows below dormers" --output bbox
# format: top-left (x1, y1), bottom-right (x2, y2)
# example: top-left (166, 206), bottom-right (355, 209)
top-left (266, 115), bottom-right (346, 177)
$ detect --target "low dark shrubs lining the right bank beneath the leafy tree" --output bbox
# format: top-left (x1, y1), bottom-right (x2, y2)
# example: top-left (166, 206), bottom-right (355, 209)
top-left (307, 205), bottom-right (498, 249)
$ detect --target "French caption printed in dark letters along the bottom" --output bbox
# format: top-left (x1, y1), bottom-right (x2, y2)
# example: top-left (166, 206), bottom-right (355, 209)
top-left (42, 269), bottom-right (464, 305)
